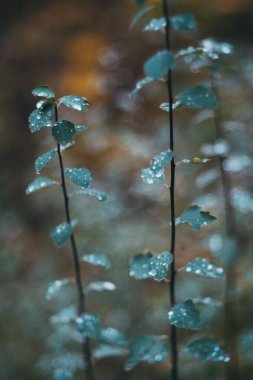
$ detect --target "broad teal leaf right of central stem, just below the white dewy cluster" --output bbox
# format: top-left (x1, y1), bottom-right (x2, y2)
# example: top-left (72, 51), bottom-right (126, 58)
top-left (179, 85), bottom-right (219, 109)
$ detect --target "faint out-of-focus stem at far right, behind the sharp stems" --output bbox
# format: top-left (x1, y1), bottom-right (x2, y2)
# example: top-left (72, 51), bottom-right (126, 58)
top-left (210, 68), bottom-right (240, 380)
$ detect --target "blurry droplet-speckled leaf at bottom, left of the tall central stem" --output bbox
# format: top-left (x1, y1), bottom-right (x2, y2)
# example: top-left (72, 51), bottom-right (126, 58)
top-left (125, 335), bottom-right (169, 371)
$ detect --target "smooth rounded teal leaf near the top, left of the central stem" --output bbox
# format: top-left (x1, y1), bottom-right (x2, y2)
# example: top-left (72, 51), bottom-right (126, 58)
top-left (144, 50), bottom-right (175, 79)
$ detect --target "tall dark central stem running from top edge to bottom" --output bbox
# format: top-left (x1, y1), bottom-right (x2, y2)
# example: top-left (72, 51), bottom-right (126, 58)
top-left (163, 0), bottom-right (178, 380)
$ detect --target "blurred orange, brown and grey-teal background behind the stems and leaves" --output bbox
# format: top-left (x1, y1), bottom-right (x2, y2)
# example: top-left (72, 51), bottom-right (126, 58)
top-left (0, 0), bottom-right (253, 380)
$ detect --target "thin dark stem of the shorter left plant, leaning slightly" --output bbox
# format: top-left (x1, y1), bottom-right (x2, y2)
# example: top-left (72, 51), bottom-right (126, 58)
top-left (55, 106), bottom-right (94, 380)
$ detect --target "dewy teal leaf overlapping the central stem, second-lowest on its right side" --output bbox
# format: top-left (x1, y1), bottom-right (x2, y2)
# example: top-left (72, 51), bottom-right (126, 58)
top-left (168, 299), bottom-right (201, 330)
